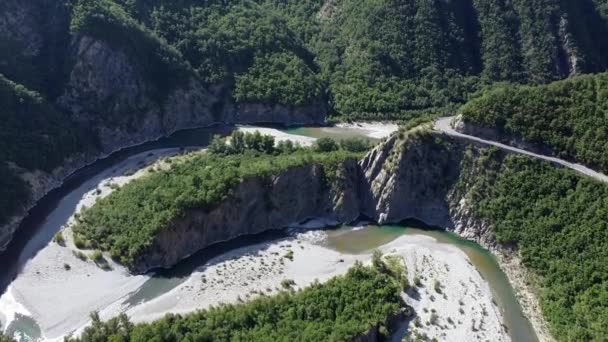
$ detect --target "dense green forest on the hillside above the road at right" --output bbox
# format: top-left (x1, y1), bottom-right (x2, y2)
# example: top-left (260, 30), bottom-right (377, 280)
top-left (459, 73), bottom-right (608, 173)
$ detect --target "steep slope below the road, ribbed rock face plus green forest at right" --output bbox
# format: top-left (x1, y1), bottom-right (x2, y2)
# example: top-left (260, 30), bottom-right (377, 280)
top-left (361, 132), bottom-right (608, 341)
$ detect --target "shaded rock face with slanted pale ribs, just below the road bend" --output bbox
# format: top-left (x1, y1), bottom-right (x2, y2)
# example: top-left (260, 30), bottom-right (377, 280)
top-left (361, 133), bottom-right (461, 228)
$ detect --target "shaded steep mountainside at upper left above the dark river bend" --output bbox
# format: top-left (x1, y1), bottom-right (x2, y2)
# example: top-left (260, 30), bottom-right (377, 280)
top-left (0, 0), bottom-right (325, 251)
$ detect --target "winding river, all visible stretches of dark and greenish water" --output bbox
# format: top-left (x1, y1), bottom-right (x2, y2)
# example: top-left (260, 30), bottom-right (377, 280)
top-left (0, 127), bottom-right (536, 341)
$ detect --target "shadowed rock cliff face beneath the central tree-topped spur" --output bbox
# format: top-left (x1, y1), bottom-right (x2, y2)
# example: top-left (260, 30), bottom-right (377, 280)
top-left (132, 161), bottom-right (360, 273)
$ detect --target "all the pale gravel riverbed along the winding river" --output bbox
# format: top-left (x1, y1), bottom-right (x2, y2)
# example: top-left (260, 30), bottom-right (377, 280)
top-left (0, 124), bottom-right (509, 341)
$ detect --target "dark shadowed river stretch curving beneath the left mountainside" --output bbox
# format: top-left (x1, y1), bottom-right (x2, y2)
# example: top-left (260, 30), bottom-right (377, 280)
top-left (0, 125), bottom-right (234, 295)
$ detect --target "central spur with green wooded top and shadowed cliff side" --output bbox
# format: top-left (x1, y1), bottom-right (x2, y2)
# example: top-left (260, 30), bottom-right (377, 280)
top-left (73, 151), bottom-right (360, 273)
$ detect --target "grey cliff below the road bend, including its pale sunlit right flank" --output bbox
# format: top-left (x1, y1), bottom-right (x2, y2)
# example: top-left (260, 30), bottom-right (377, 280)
top-left (360, 132), bottom-right (495, 247)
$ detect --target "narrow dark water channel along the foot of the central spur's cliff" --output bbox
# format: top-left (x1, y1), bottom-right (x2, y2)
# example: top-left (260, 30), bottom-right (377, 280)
top-left (123, 230), bottom-right (289, 307)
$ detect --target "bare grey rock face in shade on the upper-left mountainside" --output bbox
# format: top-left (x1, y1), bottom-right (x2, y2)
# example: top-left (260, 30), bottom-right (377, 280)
top-left (58, 36), bottom-right (214, 153)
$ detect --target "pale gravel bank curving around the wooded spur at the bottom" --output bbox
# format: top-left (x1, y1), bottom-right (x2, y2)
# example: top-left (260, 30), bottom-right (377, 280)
top-left (101, 228), bottom-right (510, 341)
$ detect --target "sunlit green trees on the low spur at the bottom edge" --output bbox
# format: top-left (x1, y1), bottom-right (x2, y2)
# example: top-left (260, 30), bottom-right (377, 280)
top-left (66, 264), bottom-right (405, 342)
